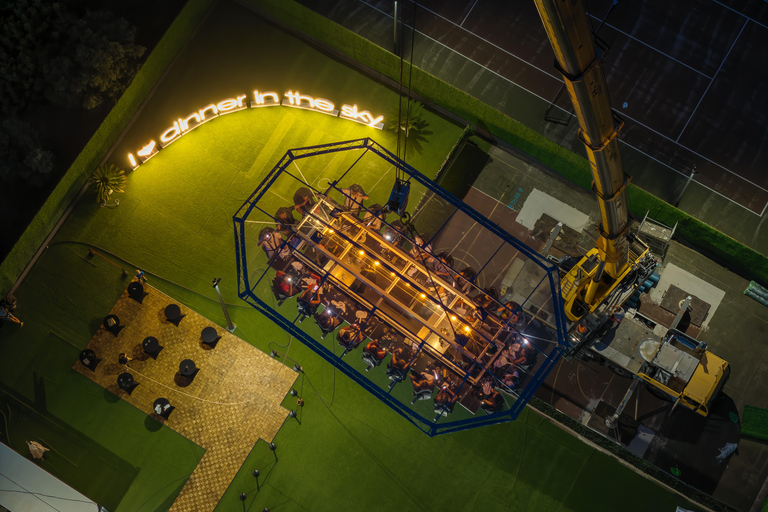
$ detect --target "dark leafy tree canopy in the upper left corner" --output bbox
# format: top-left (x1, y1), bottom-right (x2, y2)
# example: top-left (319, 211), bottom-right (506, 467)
top-left (0, 0), bottom-right (145, 183)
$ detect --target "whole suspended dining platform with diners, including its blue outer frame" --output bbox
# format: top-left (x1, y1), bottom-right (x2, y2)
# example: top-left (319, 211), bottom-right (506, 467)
top-left (233, 138), bottom-right (568, 436)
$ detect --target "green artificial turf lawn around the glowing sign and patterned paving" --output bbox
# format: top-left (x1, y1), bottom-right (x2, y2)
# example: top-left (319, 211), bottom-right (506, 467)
top-left (0, 2), bottom-right (694, 512)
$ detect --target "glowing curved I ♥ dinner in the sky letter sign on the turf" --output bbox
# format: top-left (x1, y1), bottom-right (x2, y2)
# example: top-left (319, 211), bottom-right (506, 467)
top-left (128, 90), bottom-right (384, 170)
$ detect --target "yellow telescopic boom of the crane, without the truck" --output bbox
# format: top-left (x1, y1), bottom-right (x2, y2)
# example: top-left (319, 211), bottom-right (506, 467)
top-left (535, 0), bottom-right (647, 320)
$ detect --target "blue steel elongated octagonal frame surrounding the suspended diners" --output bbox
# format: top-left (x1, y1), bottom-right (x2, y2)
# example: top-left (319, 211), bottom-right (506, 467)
top-left (233, 138), bottom-right (568, 437)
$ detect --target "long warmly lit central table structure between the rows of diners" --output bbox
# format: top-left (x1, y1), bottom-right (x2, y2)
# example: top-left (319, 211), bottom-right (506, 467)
top-left (284, 197), bottom-right (505, 392)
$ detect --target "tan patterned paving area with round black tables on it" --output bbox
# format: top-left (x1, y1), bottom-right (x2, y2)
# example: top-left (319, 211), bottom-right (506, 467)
top-left (73, 284), bottom-right (296, 512)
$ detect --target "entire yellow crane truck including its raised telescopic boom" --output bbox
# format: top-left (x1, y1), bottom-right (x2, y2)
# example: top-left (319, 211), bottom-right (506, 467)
top-left (535, 0), bottom-right (730, 423)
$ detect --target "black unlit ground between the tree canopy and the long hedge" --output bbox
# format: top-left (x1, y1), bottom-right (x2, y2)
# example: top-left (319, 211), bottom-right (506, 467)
top-left (0, 0), bottom-right (184, 261)
